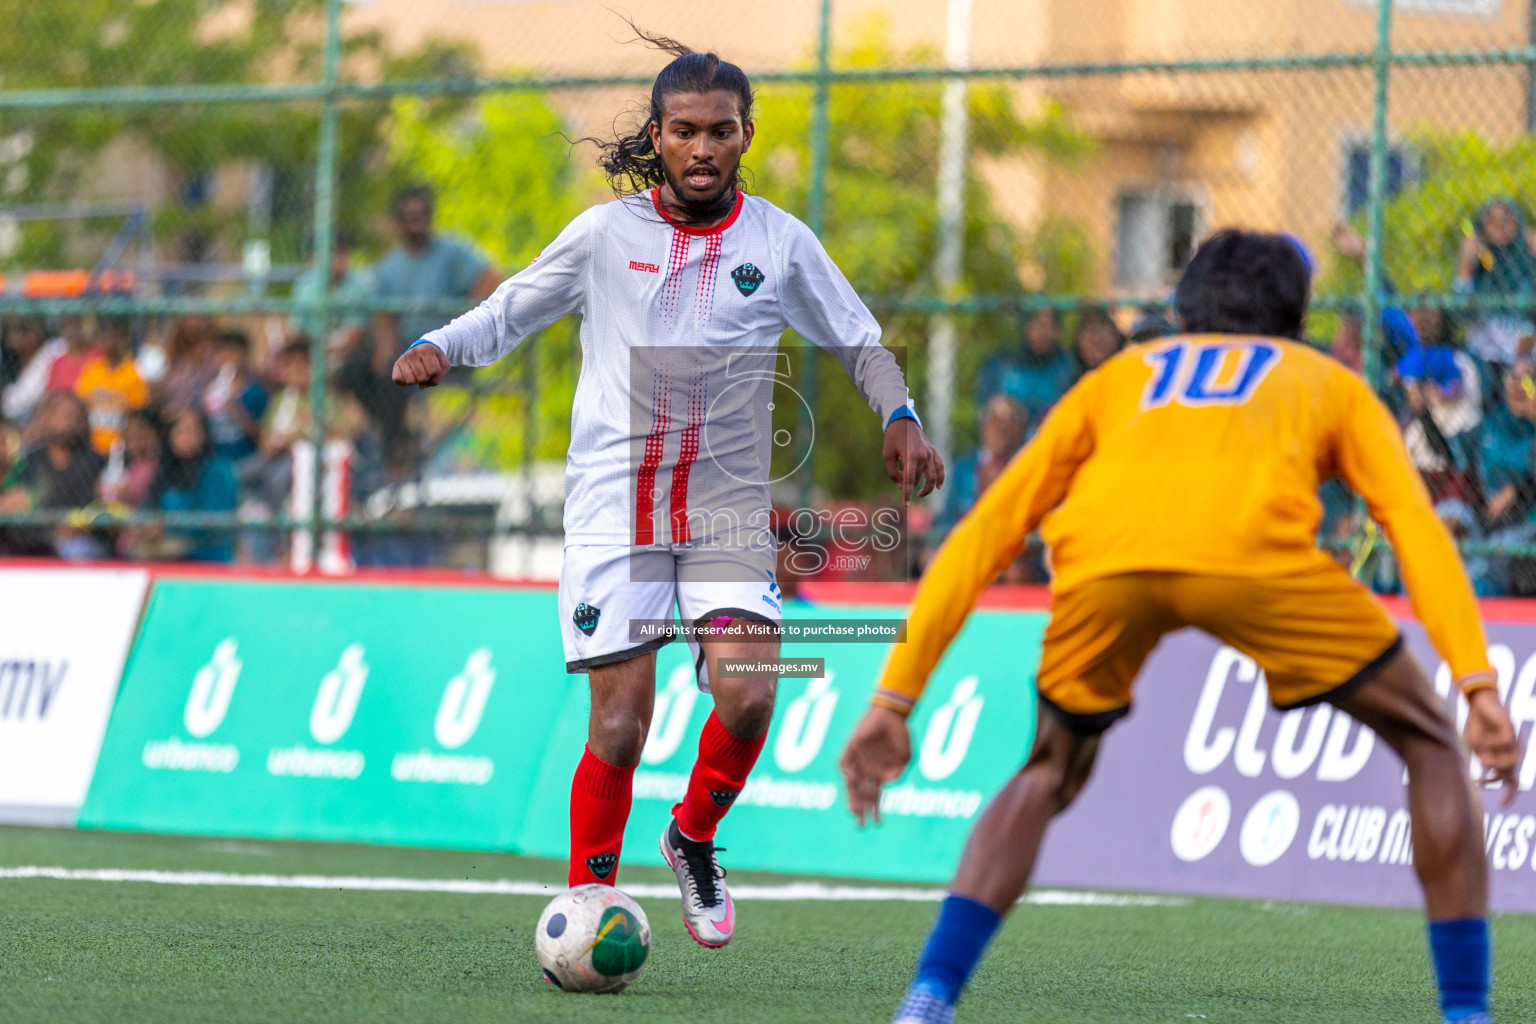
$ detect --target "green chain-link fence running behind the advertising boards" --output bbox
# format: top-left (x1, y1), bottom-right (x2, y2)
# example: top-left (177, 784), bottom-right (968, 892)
top-left (0, 0), bottom-right (1536, 593)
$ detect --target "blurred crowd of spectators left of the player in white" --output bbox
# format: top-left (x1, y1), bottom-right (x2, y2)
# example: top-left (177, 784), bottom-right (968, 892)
top-left (0, 189), bottom-right (498, 563)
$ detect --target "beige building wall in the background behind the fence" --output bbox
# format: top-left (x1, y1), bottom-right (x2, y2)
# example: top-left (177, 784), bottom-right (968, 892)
top-left (347, 0), bottom-right (1527, 292)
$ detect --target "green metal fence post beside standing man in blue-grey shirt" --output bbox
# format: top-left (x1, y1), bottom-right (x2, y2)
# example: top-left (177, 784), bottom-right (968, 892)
top-left (307, 0), bottom-right (341, 570)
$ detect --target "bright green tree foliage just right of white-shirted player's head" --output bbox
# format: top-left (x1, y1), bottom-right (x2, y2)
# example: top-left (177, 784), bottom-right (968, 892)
top-left (750, 18), bottom-right (1094, 496)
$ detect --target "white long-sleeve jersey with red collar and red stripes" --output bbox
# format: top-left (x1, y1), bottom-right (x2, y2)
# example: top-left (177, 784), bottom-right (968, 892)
top-left (425, 190), bottom-right (908, 545)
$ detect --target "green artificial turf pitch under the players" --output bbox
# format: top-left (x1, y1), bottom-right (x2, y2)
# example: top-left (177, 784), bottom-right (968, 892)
top-left (0, 827), bottom-right (1536, 1024)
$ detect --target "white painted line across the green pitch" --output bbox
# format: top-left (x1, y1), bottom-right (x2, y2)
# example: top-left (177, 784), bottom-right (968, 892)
top-left (0, 864), bottom-right (1186, 907)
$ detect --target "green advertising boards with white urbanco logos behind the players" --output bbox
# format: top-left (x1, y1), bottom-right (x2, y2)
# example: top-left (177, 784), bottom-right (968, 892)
top-left (80, 582), bottom-right (1044, 881)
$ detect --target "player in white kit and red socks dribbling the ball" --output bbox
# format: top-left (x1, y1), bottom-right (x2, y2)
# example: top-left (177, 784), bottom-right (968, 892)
top-left (393, 34), bottom-right (943, 947)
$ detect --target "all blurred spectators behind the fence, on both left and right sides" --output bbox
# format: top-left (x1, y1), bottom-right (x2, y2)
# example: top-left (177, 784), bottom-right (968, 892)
top-left (12, 189), bottom-right (1536, 583)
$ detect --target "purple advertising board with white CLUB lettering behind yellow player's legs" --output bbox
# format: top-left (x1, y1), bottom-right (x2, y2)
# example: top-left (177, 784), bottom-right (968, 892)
top-left (1037, 623), bottom-right (1536, 912)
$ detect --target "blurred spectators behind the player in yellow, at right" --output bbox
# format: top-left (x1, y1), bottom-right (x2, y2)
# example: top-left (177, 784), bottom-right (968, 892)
top-left (958, 200), bottom-right (1536, 596)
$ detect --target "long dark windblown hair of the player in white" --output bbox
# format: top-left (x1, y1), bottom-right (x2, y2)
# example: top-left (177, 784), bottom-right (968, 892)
top-left (582, 21), bottom-right (753, 197)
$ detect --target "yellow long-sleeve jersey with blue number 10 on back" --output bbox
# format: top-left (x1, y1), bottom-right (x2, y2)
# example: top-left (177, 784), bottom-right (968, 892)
top-left (874, 335), bottom-right (1491, 711)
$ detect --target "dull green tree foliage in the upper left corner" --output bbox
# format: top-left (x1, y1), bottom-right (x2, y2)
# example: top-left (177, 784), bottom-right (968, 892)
top-left (0, 0), bottom-right (473, 267)
